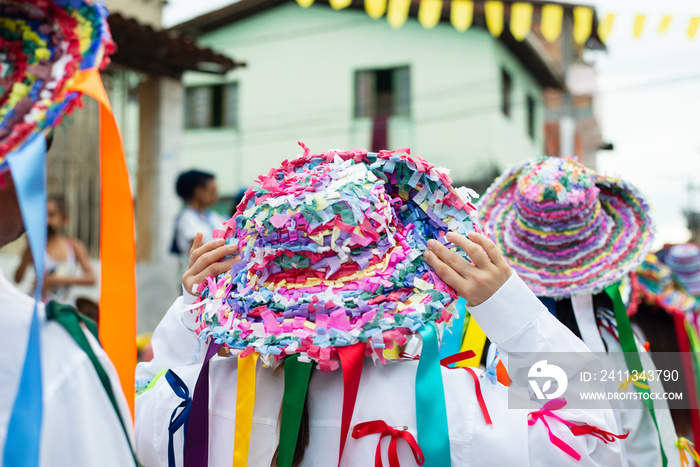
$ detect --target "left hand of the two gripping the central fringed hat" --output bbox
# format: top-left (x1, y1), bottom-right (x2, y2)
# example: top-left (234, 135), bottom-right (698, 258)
top-left (182, 232), bottom-right (241, 294)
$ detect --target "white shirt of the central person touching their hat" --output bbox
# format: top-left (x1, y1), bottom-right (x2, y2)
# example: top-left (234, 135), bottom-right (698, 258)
top-left (136, 274), bottom-right (621, 467)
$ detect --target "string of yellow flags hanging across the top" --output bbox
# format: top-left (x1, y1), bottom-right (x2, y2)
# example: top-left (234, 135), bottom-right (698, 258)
top-left (297, 0), bottom-right (700, 45)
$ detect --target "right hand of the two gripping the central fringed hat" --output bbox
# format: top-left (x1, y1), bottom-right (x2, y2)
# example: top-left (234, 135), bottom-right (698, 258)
top-left (424, 232), bottom-right (513, 306)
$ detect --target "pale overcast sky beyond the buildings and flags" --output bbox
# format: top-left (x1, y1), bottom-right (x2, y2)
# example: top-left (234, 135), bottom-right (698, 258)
top-left (164, 0), bottom-right (700, 245)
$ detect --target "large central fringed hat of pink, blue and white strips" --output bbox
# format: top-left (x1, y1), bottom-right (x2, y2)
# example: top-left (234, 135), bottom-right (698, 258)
top-left (197, 148), bottom-right (480, 371)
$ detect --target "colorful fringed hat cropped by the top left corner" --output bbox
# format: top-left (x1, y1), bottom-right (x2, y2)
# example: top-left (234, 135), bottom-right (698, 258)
top-left (0, 0), bottom-right (115, 170)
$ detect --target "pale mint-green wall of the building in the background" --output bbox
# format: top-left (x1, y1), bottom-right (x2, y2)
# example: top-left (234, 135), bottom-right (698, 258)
top-left (182, 4), bottom-right (543, 194)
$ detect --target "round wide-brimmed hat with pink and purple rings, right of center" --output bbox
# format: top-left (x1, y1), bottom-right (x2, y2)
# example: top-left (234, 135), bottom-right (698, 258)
top-left (477, 157), bottom-right (653, 298)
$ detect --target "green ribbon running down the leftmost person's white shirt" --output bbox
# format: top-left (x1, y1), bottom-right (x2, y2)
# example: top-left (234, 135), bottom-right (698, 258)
top-left (46, 301), bottom-right (140, 466)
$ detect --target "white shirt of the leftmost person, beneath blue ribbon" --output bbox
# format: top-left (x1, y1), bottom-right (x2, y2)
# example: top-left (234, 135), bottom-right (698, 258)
top-left (0, 273), bottom-right (134, 467)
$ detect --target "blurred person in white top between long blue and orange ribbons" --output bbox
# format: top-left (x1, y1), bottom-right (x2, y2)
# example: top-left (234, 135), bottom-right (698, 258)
top-left (15, 195), bottom-right (96, 304)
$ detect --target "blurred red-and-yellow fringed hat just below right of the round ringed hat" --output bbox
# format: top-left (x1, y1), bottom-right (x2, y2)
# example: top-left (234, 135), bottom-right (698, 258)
top-left (627, 254), bottom-right (698, 316)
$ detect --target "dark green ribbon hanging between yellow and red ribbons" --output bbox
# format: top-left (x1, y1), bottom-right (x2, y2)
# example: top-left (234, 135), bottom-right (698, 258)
top-left (277, 354), bottom-right (312, 467)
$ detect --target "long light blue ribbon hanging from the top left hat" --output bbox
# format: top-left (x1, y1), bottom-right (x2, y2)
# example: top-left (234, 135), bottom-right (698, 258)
top-left (2, 133), bottom-right (46, 467)
